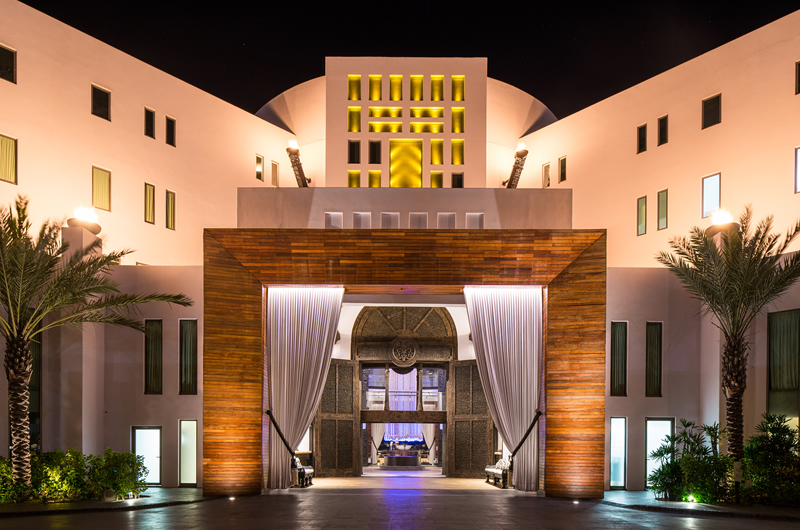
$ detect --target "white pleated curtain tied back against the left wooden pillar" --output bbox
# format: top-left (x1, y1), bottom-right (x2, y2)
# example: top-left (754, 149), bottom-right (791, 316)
top-left (267, 286), bottom-right (344, 489)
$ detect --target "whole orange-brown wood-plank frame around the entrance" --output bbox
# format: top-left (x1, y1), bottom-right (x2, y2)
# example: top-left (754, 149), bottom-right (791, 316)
top-left (203, 229), bottom-right (606, 498)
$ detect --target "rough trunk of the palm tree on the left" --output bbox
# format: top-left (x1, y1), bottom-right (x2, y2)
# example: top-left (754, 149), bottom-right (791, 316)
top-left (5, 339), bottom-right (33, 486)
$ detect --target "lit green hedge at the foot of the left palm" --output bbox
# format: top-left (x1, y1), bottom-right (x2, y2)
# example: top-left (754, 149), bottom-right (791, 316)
top-left (0, 449), bottom-right (147, 502)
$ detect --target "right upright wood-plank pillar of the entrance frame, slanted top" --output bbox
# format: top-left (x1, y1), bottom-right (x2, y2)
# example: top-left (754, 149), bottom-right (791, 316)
top-left (545, 235), bottom-right (606, 499)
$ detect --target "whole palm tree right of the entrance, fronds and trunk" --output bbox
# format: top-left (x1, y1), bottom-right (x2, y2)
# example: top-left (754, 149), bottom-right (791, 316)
top-left (656, 205), bottom-right (800, 460)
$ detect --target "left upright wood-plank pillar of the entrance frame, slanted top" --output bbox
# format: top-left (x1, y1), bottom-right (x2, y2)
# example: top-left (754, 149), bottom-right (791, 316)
top-left (203, 233), bottom-right (264, 495)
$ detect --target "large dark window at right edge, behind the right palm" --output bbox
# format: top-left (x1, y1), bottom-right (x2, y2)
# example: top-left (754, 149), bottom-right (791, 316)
top-left (767, 309), bottom-right (800, 429)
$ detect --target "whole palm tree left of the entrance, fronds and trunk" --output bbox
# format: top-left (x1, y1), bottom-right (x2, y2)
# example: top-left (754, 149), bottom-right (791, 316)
top-left (0, 197), bottom-right (192, 485)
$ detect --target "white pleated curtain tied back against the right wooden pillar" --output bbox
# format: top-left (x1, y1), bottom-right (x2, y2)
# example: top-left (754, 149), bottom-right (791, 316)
top-left (464, 287), bottom-right (542, 491)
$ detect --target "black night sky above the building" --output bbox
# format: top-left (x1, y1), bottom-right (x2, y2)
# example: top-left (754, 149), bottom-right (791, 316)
top-left (17, 0), bottom-right (800, 117)
